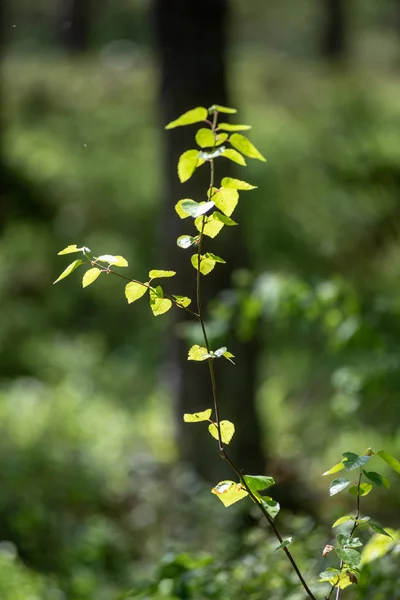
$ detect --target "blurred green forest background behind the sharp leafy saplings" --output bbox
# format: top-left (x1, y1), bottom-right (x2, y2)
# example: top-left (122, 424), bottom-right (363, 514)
top-left (0, 0), bottom-right (400, 600)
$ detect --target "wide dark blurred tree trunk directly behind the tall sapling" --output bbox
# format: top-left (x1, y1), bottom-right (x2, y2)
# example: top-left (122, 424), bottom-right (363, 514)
top-left (153, 0), bottom-right (265, 483)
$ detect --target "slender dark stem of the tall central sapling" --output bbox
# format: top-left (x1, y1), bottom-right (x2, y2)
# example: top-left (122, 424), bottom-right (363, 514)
top-left (196, 112), bottom-right (316, 600)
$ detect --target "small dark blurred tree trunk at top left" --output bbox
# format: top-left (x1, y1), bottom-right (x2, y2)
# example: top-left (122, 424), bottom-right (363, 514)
top-left (57, 0), bottom-right (92, 54)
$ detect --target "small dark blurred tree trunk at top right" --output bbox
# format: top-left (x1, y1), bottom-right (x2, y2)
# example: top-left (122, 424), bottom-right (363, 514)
top-left (321, 0), bottom-right (348, 62)
